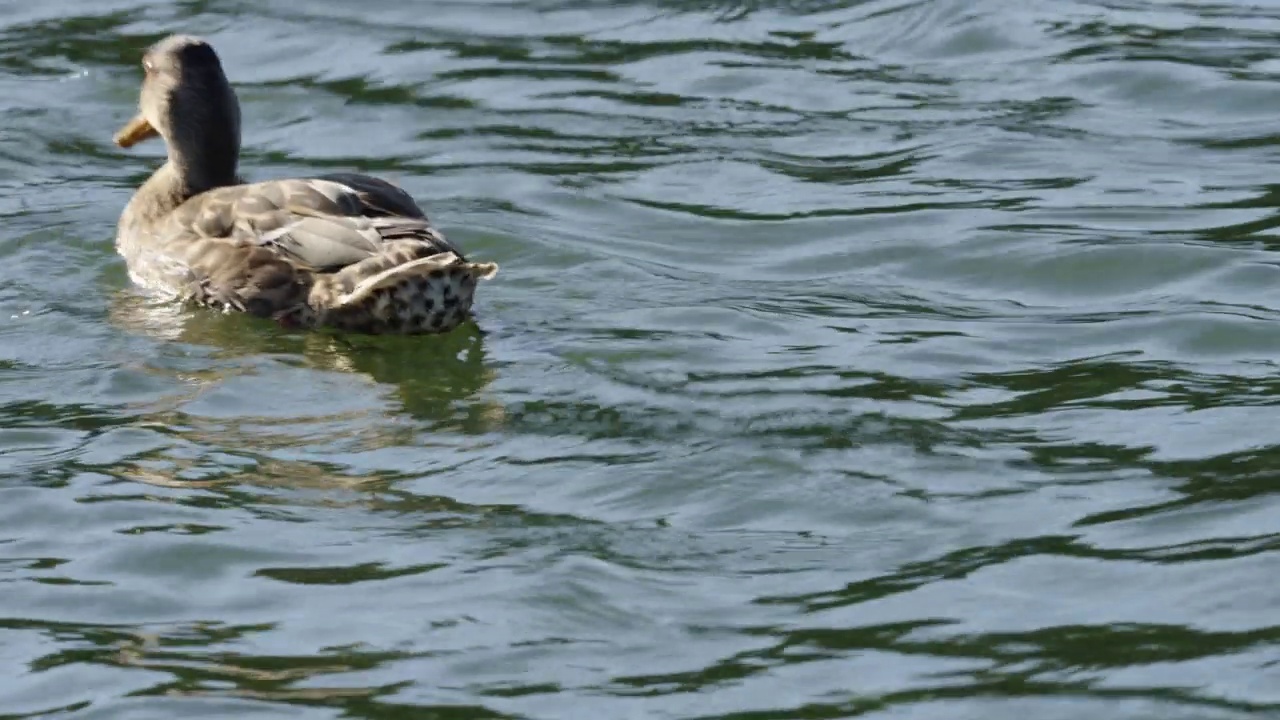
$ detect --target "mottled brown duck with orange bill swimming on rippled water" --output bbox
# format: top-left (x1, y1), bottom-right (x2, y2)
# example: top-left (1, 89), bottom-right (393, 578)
top-left (113, 35), bottom-right (498, 334)
